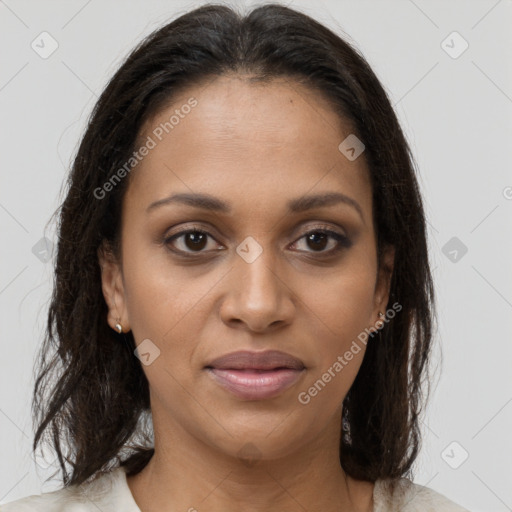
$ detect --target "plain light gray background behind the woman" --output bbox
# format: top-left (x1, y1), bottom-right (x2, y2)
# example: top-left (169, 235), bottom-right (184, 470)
top-left (0, 0), bottom-right (512, 512)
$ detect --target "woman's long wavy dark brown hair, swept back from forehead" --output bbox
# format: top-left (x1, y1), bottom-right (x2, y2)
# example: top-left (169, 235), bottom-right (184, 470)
top-left (32, 4), bottom-right (435, 486)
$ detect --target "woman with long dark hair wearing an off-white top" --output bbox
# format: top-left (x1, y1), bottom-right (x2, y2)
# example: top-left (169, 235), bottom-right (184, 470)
top-left (2, 4), bottom-right (472, 512)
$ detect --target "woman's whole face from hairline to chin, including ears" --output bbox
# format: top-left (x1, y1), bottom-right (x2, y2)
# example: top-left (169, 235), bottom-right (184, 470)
top-left (100, 76), bottom-right (393, 459)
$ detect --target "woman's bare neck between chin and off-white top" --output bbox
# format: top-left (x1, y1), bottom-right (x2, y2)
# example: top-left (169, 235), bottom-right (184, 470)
top-left (127, 410), bottom-right (373, 512)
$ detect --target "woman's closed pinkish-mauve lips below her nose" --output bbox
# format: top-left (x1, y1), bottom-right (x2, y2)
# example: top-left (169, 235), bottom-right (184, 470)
top-left (205, 350), bottom-right (305, 400)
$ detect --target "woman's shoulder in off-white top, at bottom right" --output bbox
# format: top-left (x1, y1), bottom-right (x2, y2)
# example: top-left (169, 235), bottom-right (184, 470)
top-left (374, 478), bottom-right (469, 512)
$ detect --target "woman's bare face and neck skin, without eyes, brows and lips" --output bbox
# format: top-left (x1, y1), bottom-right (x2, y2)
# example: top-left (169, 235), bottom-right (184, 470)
top-left (99, 76), bottom-right (394, 512)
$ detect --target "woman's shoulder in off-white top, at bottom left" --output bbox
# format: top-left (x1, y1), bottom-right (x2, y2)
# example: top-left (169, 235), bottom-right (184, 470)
top-left (0, 468), bottom-right (136, 512)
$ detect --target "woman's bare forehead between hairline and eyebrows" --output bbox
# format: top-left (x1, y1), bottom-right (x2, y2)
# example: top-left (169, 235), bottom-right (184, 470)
top-left (127, 76), bottom-right (371, 218)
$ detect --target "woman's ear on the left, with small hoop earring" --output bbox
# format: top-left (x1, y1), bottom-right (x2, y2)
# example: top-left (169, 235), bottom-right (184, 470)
top-left (98, 241), bottom-right (130, 332)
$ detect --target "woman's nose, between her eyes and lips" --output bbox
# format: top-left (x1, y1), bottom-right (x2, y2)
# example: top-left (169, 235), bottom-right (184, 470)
top-left (220, 246), bottom-right (295, 333)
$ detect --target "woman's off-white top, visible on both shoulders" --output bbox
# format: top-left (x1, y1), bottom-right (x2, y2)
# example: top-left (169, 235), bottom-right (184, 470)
top-left (0, 467), bottom-right (469, 512)
